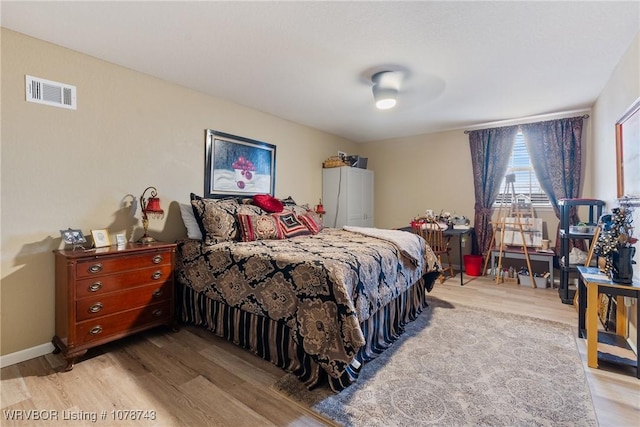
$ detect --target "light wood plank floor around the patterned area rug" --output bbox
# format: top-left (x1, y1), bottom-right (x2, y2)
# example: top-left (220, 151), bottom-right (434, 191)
top-left (0, 276), bottom-right (640, 426)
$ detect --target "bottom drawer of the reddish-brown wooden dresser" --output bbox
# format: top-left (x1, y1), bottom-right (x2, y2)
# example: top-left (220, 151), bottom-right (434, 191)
top-left (76, 300), bottom-right (171, 345)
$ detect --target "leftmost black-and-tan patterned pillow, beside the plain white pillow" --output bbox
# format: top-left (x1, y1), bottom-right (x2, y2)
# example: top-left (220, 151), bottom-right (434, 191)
top-left (191, 198), bottom-right (265, 244)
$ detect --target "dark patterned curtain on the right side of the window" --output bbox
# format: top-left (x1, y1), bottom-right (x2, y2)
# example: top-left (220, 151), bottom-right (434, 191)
top-left (521, 116), bottom-right (585, 253)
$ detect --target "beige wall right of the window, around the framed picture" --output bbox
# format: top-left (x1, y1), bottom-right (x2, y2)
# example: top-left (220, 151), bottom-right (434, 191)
top-left (592, 33), bottom-right (640, 349)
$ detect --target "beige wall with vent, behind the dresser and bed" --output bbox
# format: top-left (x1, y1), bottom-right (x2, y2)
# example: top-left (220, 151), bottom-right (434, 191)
top-left (0, 29), bottom-right (355, 355)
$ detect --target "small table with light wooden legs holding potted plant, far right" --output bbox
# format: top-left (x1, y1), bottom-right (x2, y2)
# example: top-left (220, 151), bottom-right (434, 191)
top-left (577, 267), bottom-right (640, 379)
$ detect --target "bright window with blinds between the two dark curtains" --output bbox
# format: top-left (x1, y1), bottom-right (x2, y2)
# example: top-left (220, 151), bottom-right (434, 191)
top-left (494, 132), bottom-right (551, 207)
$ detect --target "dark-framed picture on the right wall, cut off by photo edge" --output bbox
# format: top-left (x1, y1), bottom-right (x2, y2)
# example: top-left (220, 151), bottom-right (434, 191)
top-left (616, 98), bottom-right (640, 198)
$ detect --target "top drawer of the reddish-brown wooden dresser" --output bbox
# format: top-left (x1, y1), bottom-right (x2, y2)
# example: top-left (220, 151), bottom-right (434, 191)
top-left (76, 251), bottom-right (171, 278)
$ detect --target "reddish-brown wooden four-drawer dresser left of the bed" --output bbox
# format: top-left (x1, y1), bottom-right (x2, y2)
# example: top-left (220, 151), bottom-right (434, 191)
top-left (52, 242), bottom-right (176, 371)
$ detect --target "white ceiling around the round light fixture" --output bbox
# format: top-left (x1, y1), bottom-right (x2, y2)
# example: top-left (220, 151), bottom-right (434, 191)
top-left (0, 0), bottom-right (640, 142)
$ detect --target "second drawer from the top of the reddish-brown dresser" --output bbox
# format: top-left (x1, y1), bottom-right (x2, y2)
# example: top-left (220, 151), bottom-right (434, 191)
top-left (76, 264), bottom-right (173, 298)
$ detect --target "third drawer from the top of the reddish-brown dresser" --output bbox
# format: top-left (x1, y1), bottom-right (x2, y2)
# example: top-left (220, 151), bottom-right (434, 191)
top-left (76, 283), bottom-right (173, 321)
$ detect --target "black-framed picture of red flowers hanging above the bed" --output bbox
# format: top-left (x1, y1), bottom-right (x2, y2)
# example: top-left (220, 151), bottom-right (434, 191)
top-left (204, 129), bottom-right (276, 198)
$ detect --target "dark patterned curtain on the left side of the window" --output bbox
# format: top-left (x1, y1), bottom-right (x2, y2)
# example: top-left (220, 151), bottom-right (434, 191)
top-left (468, 126), bottom-right (518, 254)
